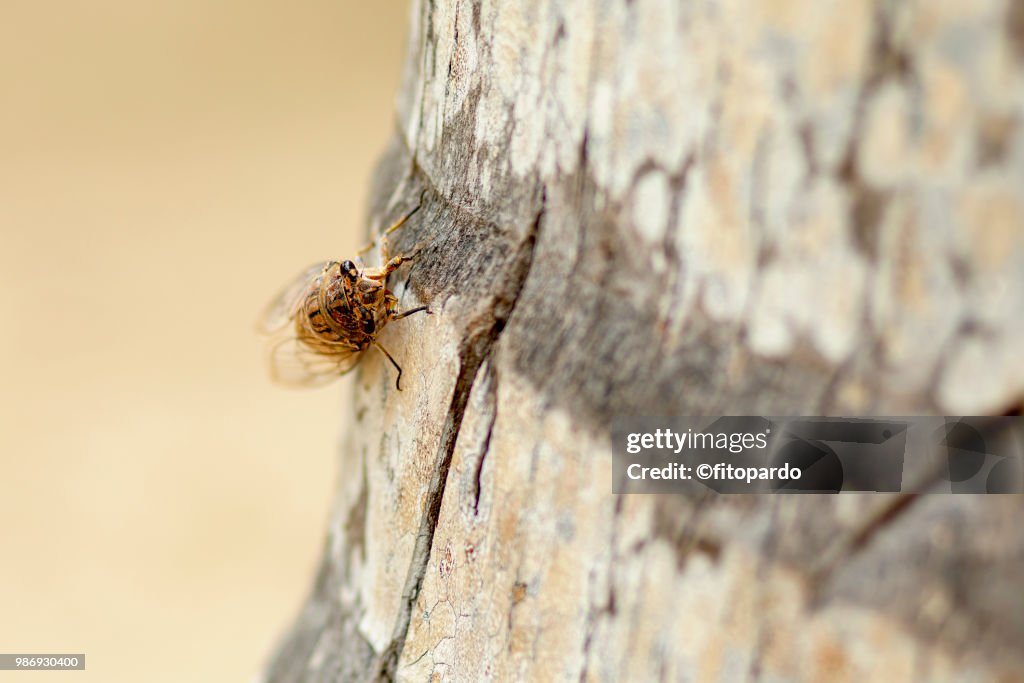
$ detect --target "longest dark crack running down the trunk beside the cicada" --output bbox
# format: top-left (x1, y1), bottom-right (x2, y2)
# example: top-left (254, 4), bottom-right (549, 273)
top-left (369, 199), bottom-right (544, 682)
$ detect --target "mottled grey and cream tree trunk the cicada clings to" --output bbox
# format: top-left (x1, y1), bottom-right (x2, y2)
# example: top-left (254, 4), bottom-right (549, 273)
top-left (265, 0), bottom-right (1024, 683)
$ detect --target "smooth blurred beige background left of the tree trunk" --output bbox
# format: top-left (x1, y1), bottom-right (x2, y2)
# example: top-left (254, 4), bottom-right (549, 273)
top-left (0, 0), bottom-right (408, 682)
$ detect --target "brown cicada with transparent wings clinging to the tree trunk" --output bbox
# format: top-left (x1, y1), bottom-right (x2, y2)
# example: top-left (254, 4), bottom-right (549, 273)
top-left (259, 196), bottom-right (430, 391)
